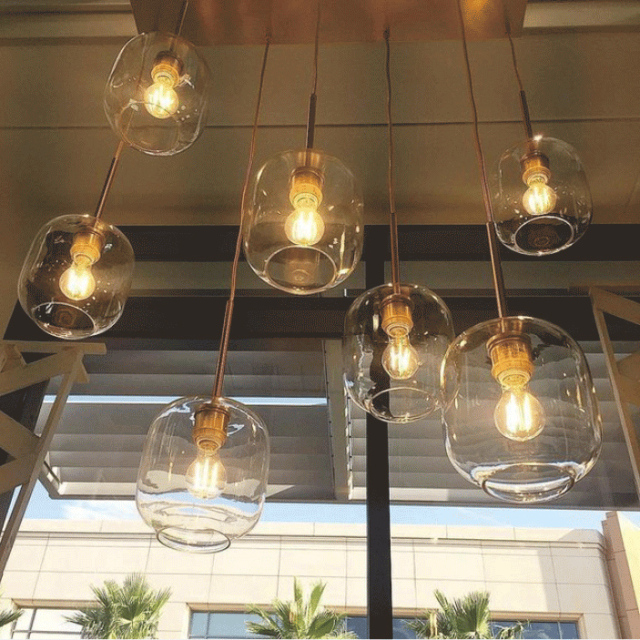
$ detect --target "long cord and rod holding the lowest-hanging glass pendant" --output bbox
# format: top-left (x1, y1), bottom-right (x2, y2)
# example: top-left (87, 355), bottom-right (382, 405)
top-left (212, 38), bottom-right (271, 401)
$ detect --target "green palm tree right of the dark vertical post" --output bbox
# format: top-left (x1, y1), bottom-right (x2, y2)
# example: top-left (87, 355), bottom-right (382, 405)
top-left (406, 589), bottom-right (523, 639)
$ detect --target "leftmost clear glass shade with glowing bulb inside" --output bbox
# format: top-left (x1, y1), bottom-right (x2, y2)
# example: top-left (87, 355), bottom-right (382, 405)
top-left (18, 215), bottom-right (134, 340)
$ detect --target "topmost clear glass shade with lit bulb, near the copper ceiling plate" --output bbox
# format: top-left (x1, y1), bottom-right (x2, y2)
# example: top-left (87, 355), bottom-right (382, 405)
top-left (104, 32), bottom-right (210, 156)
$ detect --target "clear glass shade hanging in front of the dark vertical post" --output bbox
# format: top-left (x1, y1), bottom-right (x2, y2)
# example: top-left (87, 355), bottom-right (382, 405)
top-left (343, 284), bottom-right (454, 423)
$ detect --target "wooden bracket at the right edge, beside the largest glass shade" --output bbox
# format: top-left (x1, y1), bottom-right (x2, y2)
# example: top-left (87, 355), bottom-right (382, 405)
top-left (589, 288), bottom-right (640, 496)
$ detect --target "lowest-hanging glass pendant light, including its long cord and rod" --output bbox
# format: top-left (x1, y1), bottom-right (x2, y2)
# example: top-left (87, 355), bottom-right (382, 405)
top-left (136, 43), bottom-right (269, 552)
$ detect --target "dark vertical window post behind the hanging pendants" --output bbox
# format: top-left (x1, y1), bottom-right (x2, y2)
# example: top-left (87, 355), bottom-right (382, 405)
top-left (365, 251), bottom-right (393, 638)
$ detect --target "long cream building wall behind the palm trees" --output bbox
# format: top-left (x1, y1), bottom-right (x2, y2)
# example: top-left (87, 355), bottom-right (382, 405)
top-left (2, 520), bottom-right (618, 638)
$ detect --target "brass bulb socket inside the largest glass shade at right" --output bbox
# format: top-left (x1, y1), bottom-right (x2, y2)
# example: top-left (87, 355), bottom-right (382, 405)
top-left (487, 333), bottom-right (535, 389)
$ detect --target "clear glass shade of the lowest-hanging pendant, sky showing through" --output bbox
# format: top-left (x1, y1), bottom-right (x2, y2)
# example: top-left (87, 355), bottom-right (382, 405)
top-left (136, 397), bottom-right (269, 552)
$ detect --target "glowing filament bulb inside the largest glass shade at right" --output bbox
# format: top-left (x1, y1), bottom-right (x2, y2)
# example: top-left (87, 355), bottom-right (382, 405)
top-left (493, 385), bottom-right (545, 442)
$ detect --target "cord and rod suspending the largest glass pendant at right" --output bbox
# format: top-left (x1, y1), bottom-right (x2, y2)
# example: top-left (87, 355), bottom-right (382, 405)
top-left (456, 0), bottom-right (507, 318)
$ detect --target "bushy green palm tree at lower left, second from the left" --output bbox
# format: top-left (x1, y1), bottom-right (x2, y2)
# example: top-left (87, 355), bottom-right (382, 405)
top-left (67, 574), bottom-right (171, 638)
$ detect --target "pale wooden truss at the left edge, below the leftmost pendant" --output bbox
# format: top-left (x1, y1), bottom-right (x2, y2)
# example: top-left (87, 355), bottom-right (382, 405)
top-left (0, 341), bottom-right (106, 577)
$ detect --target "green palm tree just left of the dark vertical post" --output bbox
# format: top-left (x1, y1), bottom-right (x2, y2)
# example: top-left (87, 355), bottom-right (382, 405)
top-left (247, 578), bottom-right (357, 638)
